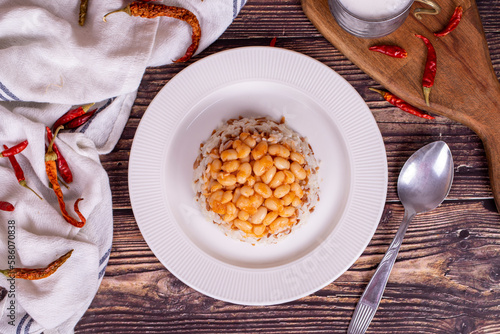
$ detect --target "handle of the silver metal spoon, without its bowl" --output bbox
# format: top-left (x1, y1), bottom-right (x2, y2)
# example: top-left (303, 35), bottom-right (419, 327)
top-left (347, 209), bottom-right (416, 334)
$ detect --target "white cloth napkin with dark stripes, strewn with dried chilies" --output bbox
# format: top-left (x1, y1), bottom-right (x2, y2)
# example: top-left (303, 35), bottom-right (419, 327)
top-left (0, 0), bottom-right (245, 334)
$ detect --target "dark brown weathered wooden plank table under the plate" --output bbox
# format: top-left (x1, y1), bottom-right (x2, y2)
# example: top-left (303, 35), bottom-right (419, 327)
top-left (75, 0), bottom-right (500, 333)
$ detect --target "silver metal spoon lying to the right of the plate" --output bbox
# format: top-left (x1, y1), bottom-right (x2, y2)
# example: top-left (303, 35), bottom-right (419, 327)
top-left (347, 141), bottom-right (453, 334)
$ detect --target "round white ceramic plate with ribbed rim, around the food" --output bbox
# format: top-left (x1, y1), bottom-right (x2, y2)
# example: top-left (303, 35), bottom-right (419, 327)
top-left (129, 47), bottom-right (387, 305)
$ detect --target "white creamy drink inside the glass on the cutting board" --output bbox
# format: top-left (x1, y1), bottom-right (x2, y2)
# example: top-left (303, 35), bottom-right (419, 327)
top-left (339, 0), bottom-right (412, 20)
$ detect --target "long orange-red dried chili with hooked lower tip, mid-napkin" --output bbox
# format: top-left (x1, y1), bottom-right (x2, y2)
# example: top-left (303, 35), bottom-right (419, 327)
top-left (45, 126), bottom-right (86, 228)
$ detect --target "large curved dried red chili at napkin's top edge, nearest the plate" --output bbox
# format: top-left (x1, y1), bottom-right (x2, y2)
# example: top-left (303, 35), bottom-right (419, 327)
top-left (103, 1), bottom-right (201, 63)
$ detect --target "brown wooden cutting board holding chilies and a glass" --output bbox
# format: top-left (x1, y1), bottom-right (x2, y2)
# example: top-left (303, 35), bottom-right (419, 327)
top-left (302, 0), bottom-right (500, 210)
